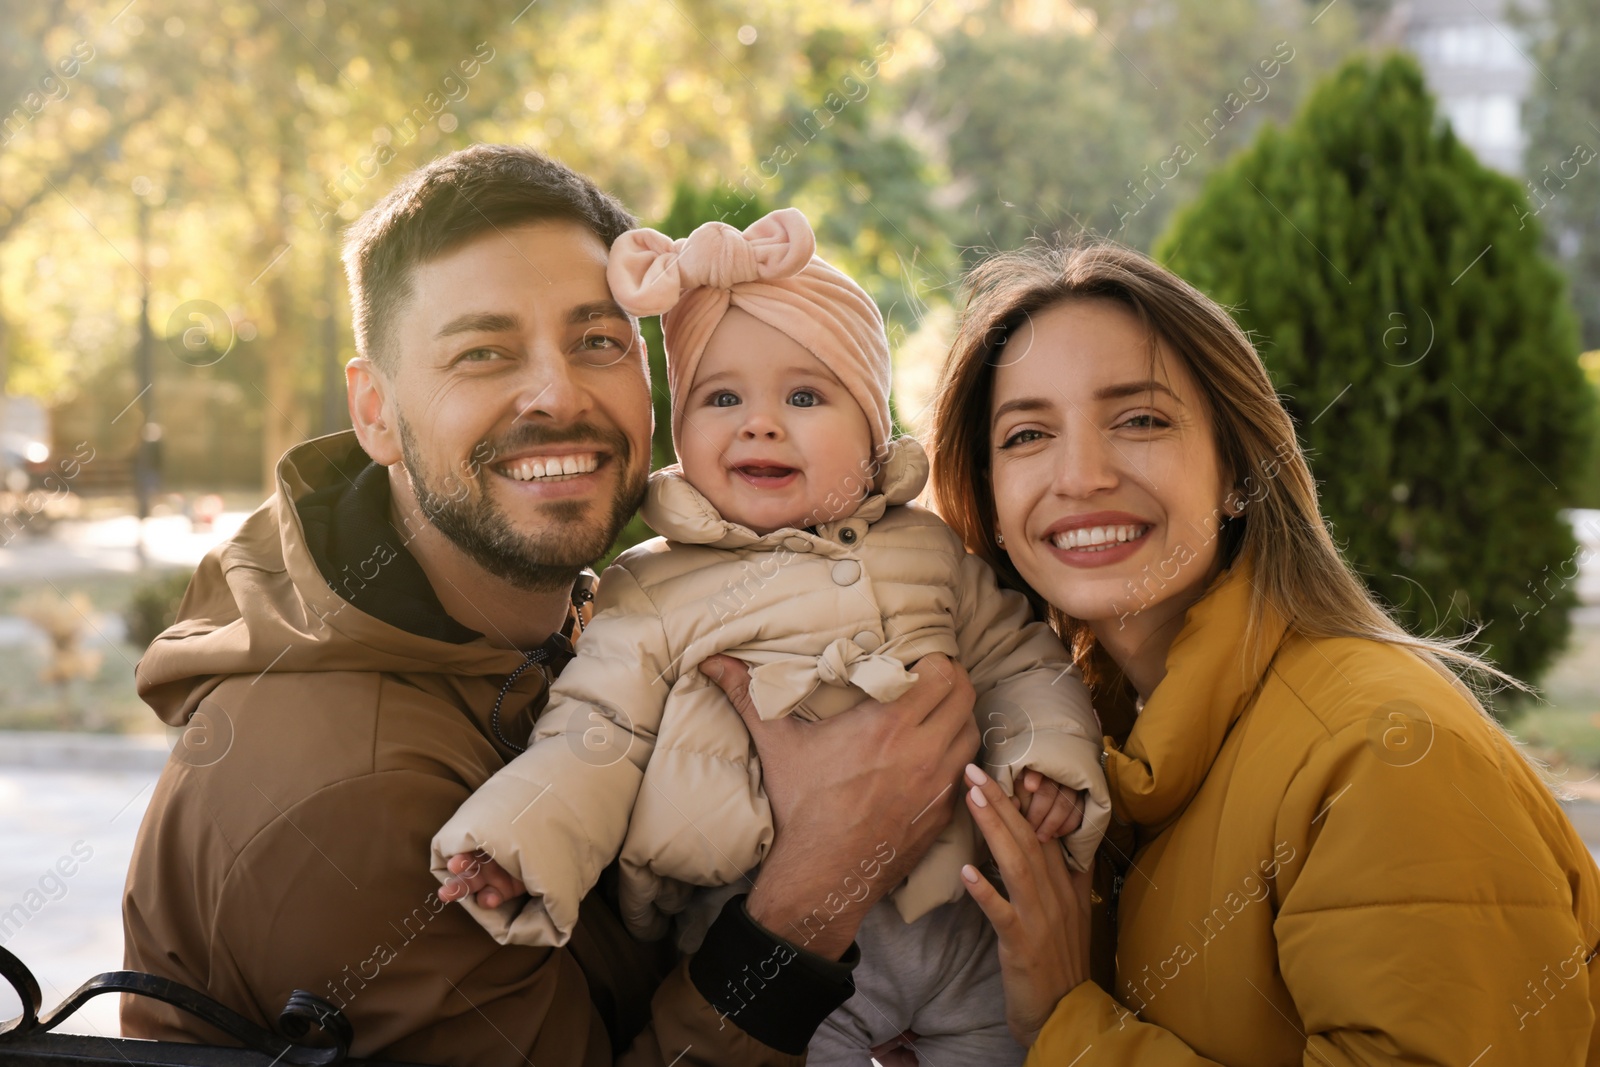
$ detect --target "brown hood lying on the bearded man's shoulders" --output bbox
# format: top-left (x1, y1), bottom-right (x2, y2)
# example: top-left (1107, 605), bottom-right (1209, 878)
top-left (134, 430), bottom-right (523, 726)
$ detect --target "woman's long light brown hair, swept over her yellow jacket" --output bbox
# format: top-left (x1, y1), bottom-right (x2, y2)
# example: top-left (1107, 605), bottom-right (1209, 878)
top-left (933, 242), bottom-right (1526, 710)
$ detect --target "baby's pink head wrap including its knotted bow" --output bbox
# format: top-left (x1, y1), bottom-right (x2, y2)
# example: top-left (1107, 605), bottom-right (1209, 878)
top-left (606, 208), bottom-right (891, 453)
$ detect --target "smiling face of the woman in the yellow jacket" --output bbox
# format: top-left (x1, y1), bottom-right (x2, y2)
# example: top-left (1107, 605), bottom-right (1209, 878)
top-left (989, 299), bottom-right (1232, 638)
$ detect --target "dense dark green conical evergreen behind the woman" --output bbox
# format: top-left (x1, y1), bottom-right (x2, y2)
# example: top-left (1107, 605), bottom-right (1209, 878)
top-left (1158, 56), bottom-right (1594, 700)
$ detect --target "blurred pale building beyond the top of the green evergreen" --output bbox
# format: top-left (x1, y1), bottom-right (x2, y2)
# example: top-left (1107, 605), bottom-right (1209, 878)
top-left (1374, 0), bottom-right (1541, 176)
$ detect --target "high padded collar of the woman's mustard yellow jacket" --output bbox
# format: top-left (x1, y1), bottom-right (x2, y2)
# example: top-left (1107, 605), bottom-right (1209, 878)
top-left (1106, 560), bottom-right (1288, 830)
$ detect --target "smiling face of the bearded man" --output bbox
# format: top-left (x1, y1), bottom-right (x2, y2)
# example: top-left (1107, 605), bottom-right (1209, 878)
top-left (384, 221), bottom-right (651, 592)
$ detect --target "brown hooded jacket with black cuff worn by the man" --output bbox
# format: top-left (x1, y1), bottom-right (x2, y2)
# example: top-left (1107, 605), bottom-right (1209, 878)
top-left (122, 434), bottom-right (851, 1067)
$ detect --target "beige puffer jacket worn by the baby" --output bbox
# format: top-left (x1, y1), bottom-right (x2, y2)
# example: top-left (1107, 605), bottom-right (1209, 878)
top-left (434, 438), bottom-right (1110, 945)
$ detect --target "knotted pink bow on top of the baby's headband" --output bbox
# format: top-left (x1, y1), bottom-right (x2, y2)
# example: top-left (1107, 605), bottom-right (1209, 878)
top-left (606, 208), bottom-right (816, 318)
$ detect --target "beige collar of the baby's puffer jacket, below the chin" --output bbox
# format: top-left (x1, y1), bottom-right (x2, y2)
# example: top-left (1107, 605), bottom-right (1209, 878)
top-left (638, 437), bottom-right (928, 549)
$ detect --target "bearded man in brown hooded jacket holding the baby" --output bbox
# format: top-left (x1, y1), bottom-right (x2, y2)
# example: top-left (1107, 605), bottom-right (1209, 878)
top-left (122, 146), bottom-right (978, 1067)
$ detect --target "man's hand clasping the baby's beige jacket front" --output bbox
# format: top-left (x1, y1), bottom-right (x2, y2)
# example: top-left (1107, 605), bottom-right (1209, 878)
top-left (701, 654), bottom-right (979, 960)
